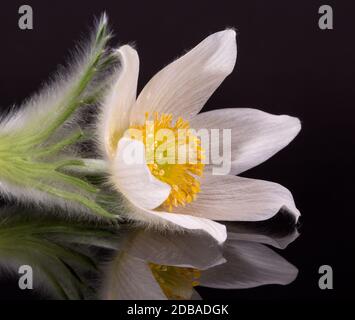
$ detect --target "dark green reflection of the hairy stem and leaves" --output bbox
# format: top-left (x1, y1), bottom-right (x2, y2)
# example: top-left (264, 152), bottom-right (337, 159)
top-left (0, 207), bottom-right (117, 299)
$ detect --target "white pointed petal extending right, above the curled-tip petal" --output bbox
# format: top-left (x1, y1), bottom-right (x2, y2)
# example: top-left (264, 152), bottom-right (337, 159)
top-left (191, 108), bottom-right (301, 174)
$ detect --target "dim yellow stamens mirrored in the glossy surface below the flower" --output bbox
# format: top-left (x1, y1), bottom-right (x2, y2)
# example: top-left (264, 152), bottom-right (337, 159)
top-left (148, 263), bottom-right (201, 300)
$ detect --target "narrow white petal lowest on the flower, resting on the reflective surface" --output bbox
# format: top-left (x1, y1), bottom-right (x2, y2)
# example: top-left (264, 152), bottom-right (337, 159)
top-left (123, 202), bottom-right (227, 243)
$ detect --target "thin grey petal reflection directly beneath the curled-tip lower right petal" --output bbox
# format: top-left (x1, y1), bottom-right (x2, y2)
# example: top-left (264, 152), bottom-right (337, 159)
top-left (227, 223), bottom-right (299, 249)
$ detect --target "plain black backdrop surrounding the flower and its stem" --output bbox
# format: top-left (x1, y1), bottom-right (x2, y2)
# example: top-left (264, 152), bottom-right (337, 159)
top-left (0, 0), bottom-right (355, 299)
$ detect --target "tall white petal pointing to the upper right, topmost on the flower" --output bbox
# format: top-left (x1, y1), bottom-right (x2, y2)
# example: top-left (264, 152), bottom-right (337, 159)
top-left (131, 30), bottom-right (237, 123)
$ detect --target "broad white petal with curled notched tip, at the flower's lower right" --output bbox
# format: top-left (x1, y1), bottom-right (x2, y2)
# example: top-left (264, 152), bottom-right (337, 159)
top-left (176, 175), bottom-right (300, 221)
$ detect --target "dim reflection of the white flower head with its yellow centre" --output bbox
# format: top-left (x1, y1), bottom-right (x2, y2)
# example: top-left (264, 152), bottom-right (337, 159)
top-left (101, 225), bottom-right (298, 299)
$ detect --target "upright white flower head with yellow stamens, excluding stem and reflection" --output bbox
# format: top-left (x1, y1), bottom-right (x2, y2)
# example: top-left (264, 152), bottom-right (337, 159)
top-left (98, 30), bottom-right (301, 242)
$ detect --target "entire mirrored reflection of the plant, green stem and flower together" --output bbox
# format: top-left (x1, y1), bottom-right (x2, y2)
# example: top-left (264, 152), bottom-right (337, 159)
top-left (0, 207), bottom-right (299, 300)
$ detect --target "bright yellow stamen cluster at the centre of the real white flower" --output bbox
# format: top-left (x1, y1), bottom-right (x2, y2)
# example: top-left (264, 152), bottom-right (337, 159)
top-left (130, 113), bottom-right (204, 211)
